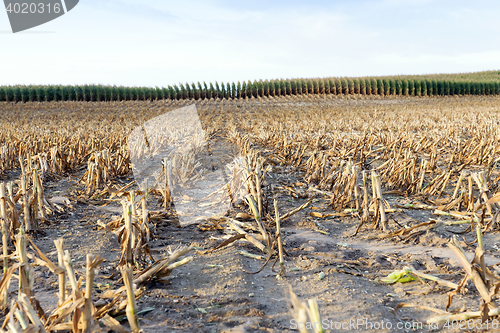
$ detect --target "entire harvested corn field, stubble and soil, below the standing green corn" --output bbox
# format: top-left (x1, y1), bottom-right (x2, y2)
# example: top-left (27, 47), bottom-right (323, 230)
top-left (0, 94), bottom-right (500, 332)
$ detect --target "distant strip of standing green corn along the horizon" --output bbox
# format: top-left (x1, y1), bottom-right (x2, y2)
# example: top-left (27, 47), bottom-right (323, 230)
top-left (0, 71), bottom-right (500, 102)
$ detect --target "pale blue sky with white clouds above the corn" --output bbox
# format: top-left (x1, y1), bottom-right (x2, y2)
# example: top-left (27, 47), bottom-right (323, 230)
top-left (0, 0), bottom-right (500, 86)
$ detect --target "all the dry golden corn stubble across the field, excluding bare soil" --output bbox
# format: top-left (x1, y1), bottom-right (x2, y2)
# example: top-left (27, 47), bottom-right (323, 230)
top-left (0, 92), bottom-right (500, 326)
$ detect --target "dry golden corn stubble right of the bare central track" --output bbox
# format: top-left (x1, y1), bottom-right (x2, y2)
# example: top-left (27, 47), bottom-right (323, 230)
top-left (204, 96), bottom-right (500, 323)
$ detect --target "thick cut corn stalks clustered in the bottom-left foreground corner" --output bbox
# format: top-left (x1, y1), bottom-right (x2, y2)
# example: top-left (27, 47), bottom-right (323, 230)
top-left (0, 227), bottom-right (193, 332)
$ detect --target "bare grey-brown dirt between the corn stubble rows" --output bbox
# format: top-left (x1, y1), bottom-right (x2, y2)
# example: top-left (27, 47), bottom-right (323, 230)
top-left (0, 94), bottom-right (500, 333)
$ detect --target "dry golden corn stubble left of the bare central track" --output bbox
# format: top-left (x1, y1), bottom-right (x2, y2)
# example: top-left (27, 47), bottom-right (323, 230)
top-left (0, 100), bottom-right (199, 332)
